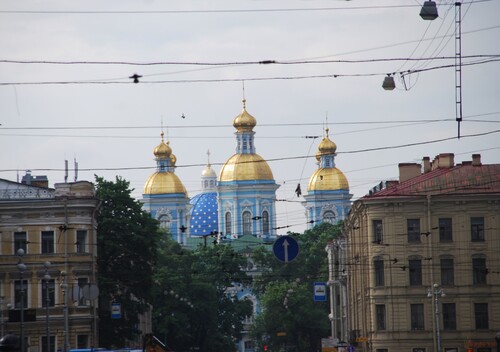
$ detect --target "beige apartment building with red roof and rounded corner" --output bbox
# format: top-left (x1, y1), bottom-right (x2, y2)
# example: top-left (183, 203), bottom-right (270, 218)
top-left (345, 154), bottom-right (500, 352)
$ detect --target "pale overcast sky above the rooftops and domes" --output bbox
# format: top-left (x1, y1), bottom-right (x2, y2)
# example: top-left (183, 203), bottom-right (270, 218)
top-left (0, 0), bottom-right (500, 231)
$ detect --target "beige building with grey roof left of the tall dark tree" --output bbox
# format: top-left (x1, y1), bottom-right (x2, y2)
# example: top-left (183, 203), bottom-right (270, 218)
top-left (0, 174), bottom-right (98, 352)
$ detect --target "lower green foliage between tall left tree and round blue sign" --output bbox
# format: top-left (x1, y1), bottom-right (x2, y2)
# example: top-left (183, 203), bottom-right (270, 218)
top-left (153, 241), bottom-right (252, 352)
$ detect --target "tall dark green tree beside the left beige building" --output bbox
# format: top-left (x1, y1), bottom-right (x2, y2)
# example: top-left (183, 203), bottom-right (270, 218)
top-left (96, 176), bottom-right (160, 347)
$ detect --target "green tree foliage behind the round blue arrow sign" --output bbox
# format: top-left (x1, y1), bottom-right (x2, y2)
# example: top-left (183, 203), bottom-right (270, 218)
top-left (252, 223), bottom-right (342, 351)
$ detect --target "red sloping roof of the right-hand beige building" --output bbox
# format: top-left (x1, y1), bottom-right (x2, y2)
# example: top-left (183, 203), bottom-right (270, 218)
top-left (363, 154), bottom-right (500, 199)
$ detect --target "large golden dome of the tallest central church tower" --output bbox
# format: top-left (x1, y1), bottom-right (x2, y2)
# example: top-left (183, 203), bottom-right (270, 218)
top-left (219, 154), bottom-right (274, 182)
